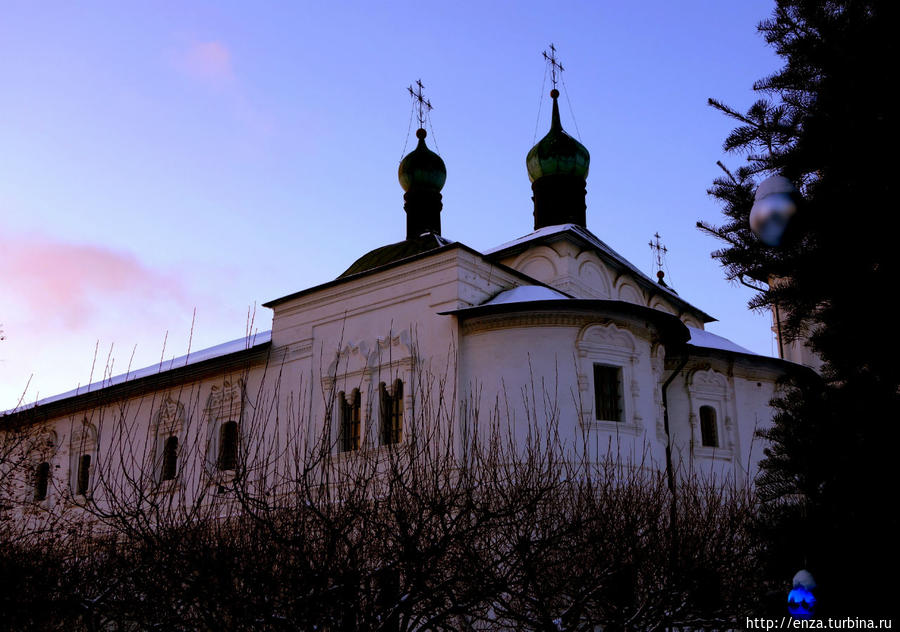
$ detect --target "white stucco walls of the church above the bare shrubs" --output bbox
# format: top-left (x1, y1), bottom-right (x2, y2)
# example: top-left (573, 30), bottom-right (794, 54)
top-left (1, 244), bottom-right (779, 520)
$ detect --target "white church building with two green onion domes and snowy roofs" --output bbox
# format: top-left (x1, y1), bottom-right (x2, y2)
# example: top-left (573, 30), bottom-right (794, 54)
top-left (0, 84), bottom-right (792, 504)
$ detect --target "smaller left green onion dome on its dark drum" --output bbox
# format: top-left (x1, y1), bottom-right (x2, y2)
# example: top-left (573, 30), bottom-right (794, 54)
top-left (397, 128), bottom-right (447, 239)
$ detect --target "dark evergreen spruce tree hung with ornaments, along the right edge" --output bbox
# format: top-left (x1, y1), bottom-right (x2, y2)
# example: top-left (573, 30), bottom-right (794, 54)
top-left (698, 0), bottom-right (900, 617)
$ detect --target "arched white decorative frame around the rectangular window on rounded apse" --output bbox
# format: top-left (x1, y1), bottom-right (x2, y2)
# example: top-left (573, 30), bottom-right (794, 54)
top-left (575, 322), bottom-right (644, 435)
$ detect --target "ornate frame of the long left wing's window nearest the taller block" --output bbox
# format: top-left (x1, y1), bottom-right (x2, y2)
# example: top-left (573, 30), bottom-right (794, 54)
top-left (204, 378), bottom-right (247, 485)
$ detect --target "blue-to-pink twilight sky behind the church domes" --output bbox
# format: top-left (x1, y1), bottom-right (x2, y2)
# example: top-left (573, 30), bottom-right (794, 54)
top-left (0, 0), bottom-right (780, 410)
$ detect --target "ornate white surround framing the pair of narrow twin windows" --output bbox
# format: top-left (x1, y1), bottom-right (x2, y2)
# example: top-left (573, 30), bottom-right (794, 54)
top-left (322, 330), bottom-right (416, 458)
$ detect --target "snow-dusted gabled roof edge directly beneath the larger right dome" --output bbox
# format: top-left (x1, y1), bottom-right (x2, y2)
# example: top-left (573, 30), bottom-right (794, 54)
top-left (484, 224), bottom-right (716, 323)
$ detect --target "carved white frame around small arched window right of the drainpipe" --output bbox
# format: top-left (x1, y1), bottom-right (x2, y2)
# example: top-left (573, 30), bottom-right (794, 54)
top-left (685, 368), bottom-right (735, 460)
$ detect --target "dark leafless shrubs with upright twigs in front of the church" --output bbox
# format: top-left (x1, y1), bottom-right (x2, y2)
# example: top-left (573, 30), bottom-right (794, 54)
top-left (0, 334), bottom-right (759, 630)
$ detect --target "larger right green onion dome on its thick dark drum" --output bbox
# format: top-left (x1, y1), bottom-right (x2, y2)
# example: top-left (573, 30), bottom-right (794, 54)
top-left (525, 88), bottom-right (591, 230)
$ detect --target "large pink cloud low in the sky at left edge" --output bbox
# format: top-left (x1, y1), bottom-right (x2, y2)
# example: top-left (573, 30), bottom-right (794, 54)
top-left (0, 235), bottom-right (186, 333)
